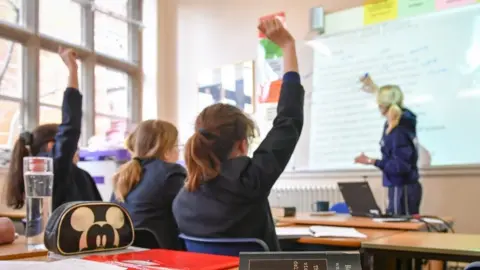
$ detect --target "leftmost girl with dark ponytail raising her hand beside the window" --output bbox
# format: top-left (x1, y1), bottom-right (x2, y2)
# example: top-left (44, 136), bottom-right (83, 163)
top-left (6, 48), bottom-right (99, 211)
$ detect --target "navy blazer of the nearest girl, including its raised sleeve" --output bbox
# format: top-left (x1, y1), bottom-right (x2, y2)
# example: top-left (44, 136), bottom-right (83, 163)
top-left (173, 72), bottom-right (305, 251)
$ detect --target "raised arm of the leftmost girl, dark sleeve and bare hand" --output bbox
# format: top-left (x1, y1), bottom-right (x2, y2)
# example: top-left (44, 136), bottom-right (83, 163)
top-left (52, 48), bottom-right (82, 209)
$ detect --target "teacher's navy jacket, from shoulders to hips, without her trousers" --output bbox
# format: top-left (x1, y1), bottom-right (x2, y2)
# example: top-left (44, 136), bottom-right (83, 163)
top-left (375, 109), bottom-right (419, 187)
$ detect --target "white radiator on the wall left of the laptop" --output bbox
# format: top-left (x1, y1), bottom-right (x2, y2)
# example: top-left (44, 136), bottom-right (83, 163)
top-left (268, 184), bottom-right (343, 212)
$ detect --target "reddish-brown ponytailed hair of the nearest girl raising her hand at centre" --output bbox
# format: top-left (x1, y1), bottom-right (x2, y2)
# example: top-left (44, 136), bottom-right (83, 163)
top-left (185, 103), bottom-right (256, 191)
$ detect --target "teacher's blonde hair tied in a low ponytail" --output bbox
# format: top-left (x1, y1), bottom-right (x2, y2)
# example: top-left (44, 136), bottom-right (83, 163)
top-left (377, 85), bottom-right (403, 134)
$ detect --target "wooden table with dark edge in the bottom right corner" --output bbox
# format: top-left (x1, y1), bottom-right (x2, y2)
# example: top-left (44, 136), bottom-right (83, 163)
top-left (362, 232), bottom-right (480, 269)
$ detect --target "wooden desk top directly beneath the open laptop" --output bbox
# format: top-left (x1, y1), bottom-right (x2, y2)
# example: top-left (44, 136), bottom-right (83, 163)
top-left (280, 213), bottom-right (453, 231)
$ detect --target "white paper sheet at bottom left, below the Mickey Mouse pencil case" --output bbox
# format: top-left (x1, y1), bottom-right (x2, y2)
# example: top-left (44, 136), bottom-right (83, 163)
top-left (23, 259), bottom-right (127, 270)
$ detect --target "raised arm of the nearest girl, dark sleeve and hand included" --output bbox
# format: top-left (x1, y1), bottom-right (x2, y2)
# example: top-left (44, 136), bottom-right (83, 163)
top-left (248, 19), bottom-right (305, 196)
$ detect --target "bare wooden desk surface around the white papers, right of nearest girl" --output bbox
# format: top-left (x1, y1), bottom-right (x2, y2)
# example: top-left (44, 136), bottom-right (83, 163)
top-left (297, 229), bottom-right (403, 248)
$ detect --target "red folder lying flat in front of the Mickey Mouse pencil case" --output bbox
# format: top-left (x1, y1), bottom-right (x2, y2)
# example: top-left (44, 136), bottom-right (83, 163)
top-left (83, 249), bottom-right (239, 270)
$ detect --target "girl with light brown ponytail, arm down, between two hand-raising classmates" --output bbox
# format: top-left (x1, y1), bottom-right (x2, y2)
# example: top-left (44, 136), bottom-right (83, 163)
top-left (112, 120), bottom-right (186, 250)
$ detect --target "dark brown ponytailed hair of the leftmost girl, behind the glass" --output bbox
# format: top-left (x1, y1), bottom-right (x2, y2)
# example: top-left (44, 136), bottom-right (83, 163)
top-left (6, 124), bottom-right (58, 209)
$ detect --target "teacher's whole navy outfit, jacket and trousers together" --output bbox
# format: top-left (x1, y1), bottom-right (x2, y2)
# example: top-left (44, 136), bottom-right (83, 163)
top-left (375, 108), bottom-right (422, 215)
